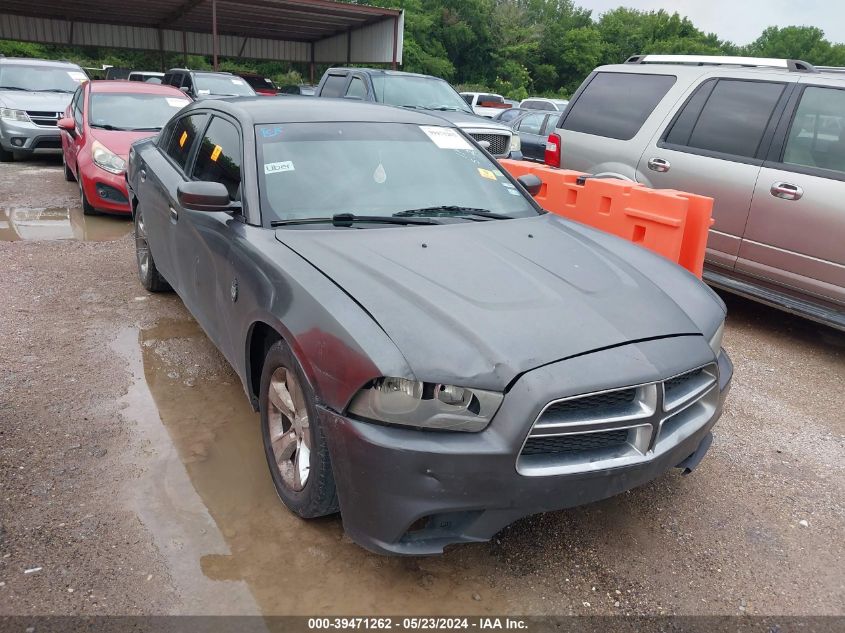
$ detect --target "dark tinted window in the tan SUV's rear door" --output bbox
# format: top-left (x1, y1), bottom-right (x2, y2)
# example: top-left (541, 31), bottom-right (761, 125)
top-left (666, 79), bottom-right (786, 158)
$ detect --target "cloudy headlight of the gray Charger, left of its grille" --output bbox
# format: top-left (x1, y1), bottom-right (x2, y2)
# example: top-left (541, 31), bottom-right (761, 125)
top-left (349, 378), bottom-right (504, 432)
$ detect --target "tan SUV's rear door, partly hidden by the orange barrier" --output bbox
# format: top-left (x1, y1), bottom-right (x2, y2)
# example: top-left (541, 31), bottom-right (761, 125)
top-left (637, 77), bottom-right (794, 269)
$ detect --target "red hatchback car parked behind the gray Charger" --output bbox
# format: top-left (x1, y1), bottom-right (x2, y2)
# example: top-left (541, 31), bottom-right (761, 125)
top-left (59, 81), bottom-right (191, 215)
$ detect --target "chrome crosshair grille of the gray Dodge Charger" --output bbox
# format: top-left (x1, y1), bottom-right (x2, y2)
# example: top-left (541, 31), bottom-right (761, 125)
top-left (516, 364), bottom-right (719, 476)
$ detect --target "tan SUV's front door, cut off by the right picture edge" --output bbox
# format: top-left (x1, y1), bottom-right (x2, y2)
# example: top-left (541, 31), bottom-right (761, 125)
top-left (736, 81), bottom-right (845, 306)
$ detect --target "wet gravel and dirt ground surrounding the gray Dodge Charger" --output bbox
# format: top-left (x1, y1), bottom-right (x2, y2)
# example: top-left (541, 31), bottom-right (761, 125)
top-left (0, 161), bottom-right (845, 615)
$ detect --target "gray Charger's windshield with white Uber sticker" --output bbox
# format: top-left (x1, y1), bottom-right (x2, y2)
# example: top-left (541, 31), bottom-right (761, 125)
top-left (256, 122), bottom-right (537, 222)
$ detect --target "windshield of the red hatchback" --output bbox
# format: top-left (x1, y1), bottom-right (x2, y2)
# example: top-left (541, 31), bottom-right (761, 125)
top-left (88, 93), bottom-right (191, 130)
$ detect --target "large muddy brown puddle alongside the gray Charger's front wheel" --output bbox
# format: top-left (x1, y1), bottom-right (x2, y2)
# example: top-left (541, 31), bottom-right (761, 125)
top-left (116, 321), bottom-right (511, 615)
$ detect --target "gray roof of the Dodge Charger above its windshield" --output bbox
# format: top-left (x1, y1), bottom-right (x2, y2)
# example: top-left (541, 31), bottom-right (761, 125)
top-left (186, 96), bottom-right (456, 127)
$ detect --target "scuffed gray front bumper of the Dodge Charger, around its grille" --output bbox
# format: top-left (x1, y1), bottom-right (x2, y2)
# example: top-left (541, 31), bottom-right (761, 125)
top-left (321, 336), bottom-right (733, 555)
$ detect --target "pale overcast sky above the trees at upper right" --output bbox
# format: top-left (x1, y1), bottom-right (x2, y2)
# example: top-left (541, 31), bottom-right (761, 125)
top-left (575, 0), bottom-right (845, 44)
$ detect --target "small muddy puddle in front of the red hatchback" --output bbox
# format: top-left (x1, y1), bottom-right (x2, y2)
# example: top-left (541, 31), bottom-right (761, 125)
top-left (0, 207), bottom-right (132, 242)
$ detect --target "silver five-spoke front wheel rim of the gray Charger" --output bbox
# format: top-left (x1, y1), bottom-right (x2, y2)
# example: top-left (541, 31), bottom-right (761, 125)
top-left (268, 367), bottom-right (311, 492)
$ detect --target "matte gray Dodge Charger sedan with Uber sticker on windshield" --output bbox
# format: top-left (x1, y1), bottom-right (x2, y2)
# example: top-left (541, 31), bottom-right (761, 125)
top-left (127, 98), bottom-right (733, 554)
